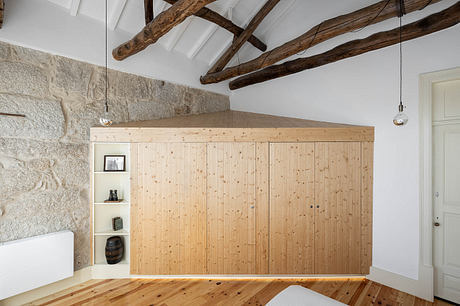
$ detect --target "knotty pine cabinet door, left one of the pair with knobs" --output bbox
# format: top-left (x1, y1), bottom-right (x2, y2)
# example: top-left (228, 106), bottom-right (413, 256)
top-left (269, 143), bottom-right (315, 274)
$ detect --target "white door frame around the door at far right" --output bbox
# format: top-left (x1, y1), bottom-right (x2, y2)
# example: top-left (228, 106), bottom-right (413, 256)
top-left (418, 67), bottom-right (460, 300)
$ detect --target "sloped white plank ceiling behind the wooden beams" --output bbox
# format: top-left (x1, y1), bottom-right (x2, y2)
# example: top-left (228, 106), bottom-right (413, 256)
top-left (48, 0), bottom-right (296, 65)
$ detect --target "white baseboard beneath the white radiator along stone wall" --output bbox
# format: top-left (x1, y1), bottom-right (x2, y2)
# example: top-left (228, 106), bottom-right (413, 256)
top-left (0, 267), bottom-right (92, 306)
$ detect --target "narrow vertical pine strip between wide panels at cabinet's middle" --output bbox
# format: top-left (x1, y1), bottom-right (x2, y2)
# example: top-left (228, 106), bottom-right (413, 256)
top-left (255, 142), bottom-right (270, 274)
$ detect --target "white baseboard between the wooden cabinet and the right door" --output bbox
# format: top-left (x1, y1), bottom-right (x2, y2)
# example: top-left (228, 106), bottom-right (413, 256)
top-left (367, 266), bottom-right (434, 302)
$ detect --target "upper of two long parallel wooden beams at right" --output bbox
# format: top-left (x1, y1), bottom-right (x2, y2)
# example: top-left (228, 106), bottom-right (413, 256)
top-left (200, 0), bottom-right (441, 84)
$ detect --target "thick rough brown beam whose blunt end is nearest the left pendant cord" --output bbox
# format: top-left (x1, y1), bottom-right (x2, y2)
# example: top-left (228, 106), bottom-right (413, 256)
top-left (112, 0), bottom-right (216, 61)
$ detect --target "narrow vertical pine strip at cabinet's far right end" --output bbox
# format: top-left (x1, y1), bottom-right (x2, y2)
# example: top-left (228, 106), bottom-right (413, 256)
top-left (360, 142), bottom-right (374, 274)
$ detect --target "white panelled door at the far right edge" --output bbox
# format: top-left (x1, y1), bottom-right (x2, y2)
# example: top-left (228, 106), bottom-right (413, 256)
top-left (433, 80), bottom-right (460, 303)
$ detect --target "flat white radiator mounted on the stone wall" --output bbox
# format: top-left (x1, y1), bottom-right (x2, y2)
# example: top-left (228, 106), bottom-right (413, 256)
top-left (0, 231), bottom-right (73, 300)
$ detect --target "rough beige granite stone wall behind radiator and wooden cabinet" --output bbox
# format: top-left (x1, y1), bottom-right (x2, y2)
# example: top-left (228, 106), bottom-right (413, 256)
top-left (0, 42), bottom-right (229, 270)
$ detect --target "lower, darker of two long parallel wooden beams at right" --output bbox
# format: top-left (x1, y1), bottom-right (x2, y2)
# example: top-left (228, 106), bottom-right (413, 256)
top-left (230, 1), bottom-right (460, 90)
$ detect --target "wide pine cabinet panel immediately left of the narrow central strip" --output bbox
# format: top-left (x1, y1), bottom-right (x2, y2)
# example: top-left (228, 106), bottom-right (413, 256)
top-left (206, 143), bottom-right (256, 274)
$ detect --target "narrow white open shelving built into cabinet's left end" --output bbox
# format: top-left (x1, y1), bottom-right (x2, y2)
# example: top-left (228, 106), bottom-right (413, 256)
top-left (92, 143), bottom-right (130, 275)
